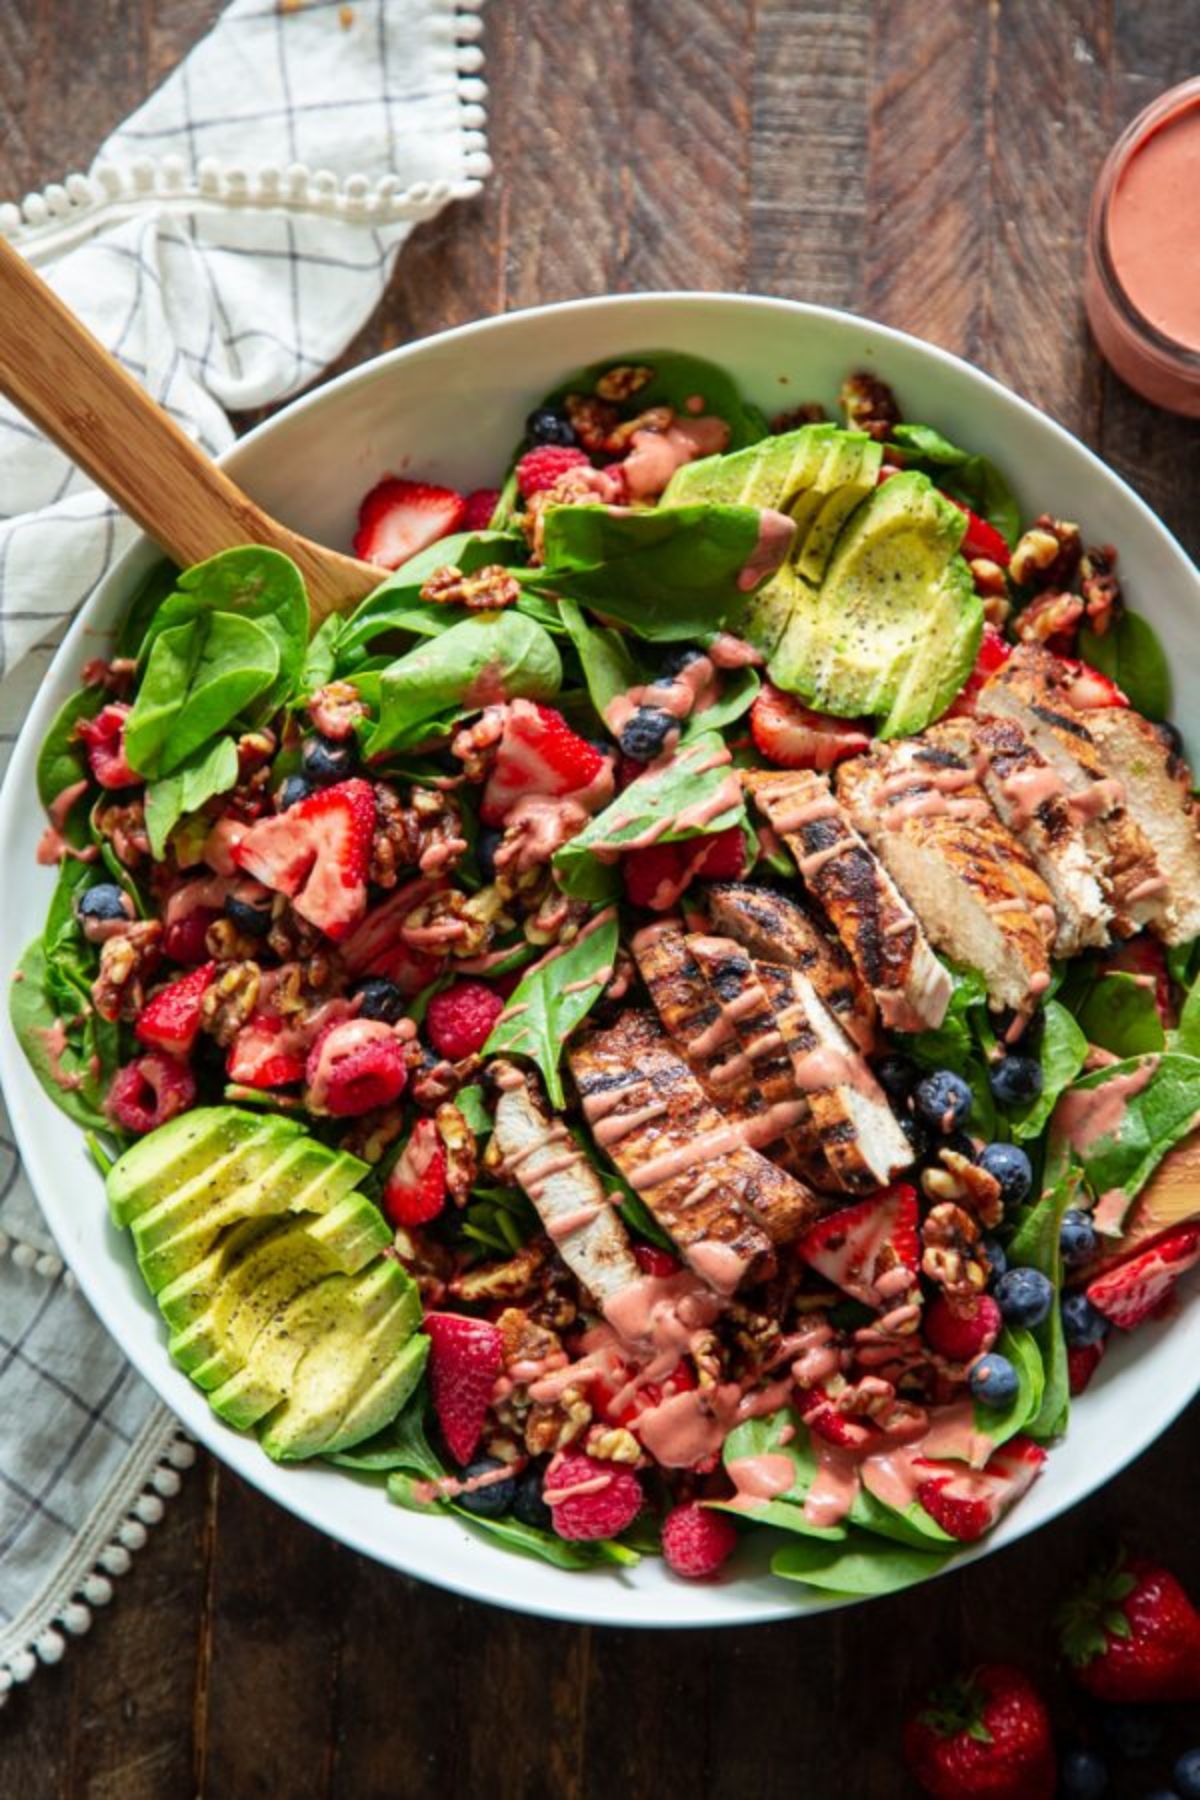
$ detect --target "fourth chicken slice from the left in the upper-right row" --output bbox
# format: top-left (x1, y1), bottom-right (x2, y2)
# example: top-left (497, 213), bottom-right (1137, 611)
top-left (977, 644), bottom-right (1175, 936)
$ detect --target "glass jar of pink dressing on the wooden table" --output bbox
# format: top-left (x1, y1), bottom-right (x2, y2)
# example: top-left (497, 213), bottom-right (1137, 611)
top-left (1083, 76), bottom-right (1200, 418)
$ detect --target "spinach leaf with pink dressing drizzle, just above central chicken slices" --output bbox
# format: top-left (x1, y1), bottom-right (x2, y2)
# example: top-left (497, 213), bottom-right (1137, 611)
top-left (554, 731), bottom-right (747, 898)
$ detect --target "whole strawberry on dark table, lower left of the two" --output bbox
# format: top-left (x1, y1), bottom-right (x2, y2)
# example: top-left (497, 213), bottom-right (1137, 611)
top-left (905, 1663), bottom-right (1056, 1800)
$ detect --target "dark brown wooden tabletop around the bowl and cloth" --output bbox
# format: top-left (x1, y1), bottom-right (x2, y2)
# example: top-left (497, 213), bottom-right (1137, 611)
top-left (0, 0), bottom-right (1200, 1800)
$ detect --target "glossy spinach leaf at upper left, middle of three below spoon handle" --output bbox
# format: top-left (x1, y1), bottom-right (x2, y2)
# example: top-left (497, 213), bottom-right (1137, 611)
top-left (126, 612), bottom-right (279, 779)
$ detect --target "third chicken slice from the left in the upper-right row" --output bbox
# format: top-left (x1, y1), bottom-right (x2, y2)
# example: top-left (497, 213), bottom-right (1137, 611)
top-left (963, 716), bottom-right (1112, 956)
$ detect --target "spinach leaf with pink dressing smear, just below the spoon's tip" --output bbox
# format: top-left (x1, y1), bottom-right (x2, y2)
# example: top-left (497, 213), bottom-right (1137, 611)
top-left (367, 612), bottom-right (563, 756)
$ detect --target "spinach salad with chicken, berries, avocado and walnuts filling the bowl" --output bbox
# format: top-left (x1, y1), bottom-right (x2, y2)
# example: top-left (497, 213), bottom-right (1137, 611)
top-left (11, 349), bottom-right (1200, 1595)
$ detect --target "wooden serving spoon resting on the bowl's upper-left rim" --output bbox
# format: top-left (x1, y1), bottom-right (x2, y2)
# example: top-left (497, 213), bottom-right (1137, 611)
top-left (0, 238), bottom-right (379, 625)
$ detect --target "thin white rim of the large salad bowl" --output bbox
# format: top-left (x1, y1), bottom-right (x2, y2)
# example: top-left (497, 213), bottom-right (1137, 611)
top-left (0, 288), bottom-right (1200, 1629)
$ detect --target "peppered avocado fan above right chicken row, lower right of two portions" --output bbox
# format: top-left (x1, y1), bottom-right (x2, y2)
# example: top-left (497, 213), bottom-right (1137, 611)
top-left (770, 472), bottom-right (982, 738)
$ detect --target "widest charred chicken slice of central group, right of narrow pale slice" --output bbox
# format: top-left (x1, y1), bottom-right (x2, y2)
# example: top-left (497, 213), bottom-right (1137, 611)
top-left (569, 1010), bottom-right (822, 1294)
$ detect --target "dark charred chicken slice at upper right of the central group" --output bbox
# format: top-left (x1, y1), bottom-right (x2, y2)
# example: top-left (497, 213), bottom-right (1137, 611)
top-left (702, 882), bottom-right (876, 1055)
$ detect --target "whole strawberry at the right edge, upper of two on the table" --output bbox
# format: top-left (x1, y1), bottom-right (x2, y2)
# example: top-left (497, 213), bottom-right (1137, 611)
top-left (1058, 1555), bottom-right (1200, 1701)
